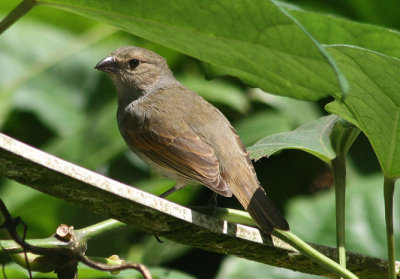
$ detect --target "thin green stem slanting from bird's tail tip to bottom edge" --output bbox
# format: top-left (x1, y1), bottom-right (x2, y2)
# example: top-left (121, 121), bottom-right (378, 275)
top-left (272, 230), bottom-right (358, 279)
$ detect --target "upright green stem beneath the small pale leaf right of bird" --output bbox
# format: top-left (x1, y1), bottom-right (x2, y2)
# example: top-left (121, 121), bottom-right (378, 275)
top-left (332, 155), bottom-right (346, 276)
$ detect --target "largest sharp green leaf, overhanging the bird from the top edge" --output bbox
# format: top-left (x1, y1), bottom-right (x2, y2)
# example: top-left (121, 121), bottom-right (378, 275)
top-left (37, 0), bottom-right (347, 100)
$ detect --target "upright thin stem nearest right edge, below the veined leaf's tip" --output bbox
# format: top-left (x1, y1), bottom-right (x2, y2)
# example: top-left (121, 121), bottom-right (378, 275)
top-left (384, 178), bottom-right (396, 279)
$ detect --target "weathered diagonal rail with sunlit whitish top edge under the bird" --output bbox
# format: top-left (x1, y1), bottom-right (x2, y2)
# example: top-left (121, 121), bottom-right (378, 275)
top-left (0, 133), bottom-right (400, 278)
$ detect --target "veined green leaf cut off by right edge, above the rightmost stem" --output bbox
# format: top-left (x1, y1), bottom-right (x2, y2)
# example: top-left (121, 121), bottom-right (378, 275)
top-left (326, 46), bottom-right (400, 178)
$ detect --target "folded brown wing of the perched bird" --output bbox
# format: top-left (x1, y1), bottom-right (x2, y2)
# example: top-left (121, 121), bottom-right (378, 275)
top-left (126, 125), bottom-right (232, 196)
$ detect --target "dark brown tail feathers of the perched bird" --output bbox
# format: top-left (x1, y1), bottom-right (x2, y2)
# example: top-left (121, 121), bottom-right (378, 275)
top-left (246, 187), bottom-right (289, 234)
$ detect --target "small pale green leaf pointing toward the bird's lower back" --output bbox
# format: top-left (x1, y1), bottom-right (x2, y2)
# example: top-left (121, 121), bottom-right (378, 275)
top-left (248, 115), bottom-right (340, 163)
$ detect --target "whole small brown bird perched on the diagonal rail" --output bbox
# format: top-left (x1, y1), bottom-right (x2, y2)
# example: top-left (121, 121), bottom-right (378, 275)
top-left (95, 46), bottom-right (289, 234)
